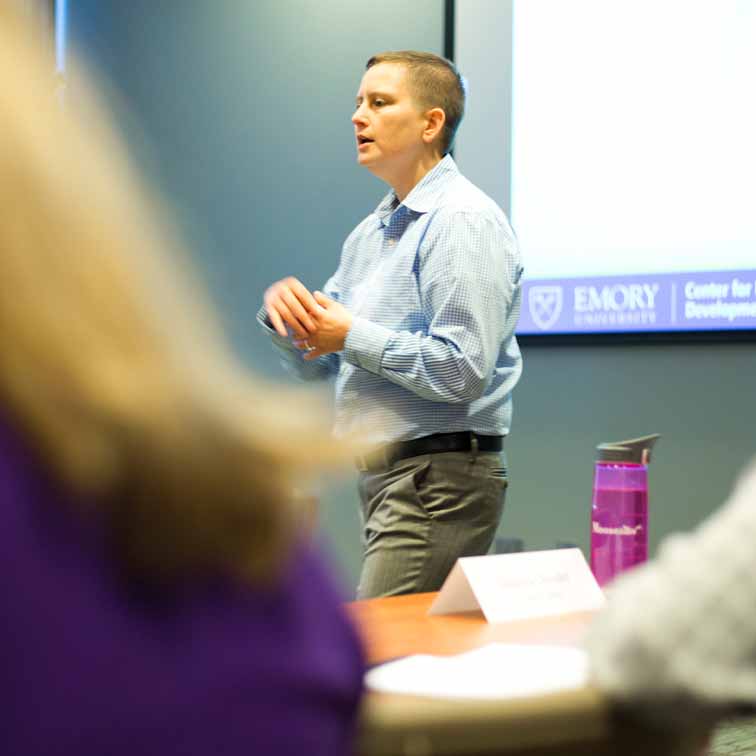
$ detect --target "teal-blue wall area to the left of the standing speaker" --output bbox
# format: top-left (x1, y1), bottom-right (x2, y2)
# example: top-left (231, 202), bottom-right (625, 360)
top-left (68, 0), bottom-right (444, 583)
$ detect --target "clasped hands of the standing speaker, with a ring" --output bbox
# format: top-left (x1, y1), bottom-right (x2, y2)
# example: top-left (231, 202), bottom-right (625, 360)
top-left (264, 276), bottom-right (352, 360)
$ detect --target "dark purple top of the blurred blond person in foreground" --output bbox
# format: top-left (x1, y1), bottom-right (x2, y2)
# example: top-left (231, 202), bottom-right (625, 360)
top-left (0, 417), bottom-right (363, 756)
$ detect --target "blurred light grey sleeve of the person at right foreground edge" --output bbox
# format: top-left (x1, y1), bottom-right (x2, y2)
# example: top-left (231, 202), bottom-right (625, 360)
top-left (586, 460), bottom-right (756, 726)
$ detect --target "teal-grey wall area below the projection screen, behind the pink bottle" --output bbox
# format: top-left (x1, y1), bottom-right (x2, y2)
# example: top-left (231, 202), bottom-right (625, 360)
top-left (505, 343), bottom-right (756, 553)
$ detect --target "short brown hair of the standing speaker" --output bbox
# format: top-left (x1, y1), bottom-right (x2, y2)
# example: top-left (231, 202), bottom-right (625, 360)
top-left (365, 50), bottom-right (465, 155)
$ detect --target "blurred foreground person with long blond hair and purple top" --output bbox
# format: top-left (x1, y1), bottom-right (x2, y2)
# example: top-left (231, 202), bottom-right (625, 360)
top-left (0, 2), bottom-right (362, 756)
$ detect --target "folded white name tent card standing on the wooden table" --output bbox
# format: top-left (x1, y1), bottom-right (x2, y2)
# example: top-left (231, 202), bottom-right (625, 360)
top-left (428, 548), bottom-right (605, 622)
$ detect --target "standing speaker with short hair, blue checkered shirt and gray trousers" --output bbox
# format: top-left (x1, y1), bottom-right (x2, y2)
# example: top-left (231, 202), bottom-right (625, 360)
top-left (259, 51), bottom-right (522, 598)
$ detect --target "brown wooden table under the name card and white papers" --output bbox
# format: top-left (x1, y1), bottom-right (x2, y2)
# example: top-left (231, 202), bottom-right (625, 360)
top-left (348, 593), bottom-right (707, 756)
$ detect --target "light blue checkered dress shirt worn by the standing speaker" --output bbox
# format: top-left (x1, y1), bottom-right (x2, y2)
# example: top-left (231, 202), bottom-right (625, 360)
top-left (258, 155), bottom-right (522, 443)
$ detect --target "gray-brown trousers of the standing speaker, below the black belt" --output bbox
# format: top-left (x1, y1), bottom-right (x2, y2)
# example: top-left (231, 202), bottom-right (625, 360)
top-left (357, 451), bottom-right (507, 599)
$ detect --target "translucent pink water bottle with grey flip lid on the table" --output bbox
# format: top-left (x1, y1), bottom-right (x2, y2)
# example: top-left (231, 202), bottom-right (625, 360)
top-left (591, 433), bottom-right (659, 586)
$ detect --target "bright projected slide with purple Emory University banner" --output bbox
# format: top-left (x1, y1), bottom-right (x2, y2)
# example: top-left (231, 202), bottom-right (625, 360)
top-left (511, 0), bottom-right (756, 333)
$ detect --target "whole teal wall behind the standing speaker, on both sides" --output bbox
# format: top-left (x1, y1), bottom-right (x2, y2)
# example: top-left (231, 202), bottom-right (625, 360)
top-left (69, 0), bottom-right (756, 582)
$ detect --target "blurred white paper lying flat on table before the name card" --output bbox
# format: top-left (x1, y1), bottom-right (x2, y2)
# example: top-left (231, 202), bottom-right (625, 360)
top-left (365, 643), bottom-right (588, 698)
